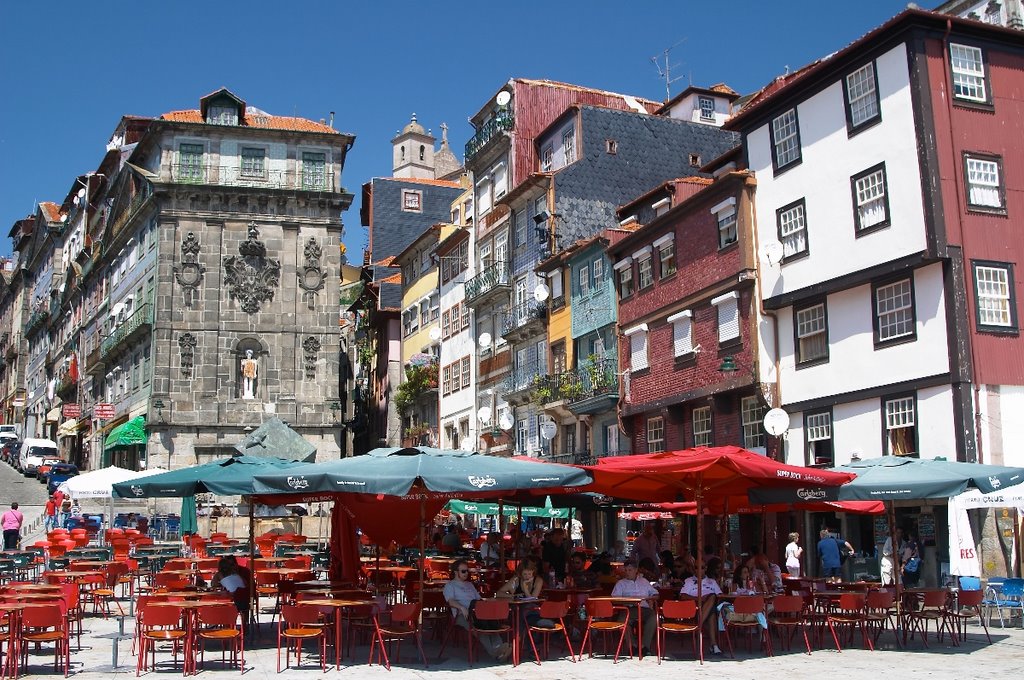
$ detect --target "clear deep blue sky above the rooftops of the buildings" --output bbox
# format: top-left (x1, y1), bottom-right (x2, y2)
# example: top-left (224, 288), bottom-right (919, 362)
top-left (0, 0), bottom-right (913, 261)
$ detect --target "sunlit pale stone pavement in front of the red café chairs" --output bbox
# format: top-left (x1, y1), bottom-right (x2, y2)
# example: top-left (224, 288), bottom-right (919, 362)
top-left (23, 604), bottom-right (1024, 680)
